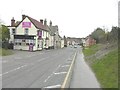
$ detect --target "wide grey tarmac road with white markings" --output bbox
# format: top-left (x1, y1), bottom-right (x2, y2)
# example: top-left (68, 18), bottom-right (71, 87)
top-left (0, 47), bottom-right (77, 88)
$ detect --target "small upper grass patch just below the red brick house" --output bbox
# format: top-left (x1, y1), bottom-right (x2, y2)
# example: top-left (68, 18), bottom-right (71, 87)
top-left (83, 44), bottom-right (101, 56)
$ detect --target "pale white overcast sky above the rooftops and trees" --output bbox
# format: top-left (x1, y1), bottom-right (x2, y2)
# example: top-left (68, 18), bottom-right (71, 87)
top-left (0, 0), bottom-right (119, 37)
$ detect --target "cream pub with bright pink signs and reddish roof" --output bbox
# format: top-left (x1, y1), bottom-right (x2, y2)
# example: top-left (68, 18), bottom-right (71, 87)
top-left (8, 15), bottom-right (49, 51)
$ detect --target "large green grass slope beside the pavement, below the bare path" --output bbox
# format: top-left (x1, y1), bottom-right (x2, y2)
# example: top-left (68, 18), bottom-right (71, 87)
top-left (92, 50), bottom-right (118, 88)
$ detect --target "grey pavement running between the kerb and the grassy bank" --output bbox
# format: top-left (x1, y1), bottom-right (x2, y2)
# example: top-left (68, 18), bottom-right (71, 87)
top-left (70, 48), bottom-right (100, 88)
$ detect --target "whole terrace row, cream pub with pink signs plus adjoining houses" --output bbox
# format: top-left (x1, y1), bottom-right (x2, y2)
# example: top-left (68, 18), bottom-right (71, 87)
top-left (8, 15), bottom-right (64, 51)
